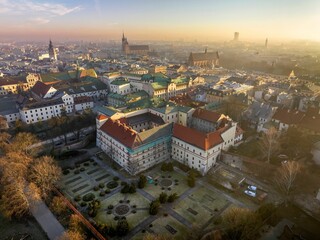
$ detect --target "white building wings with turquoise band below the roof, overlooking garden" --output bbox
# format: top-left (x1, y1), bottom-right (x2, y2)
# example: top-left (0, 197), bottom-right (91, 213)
top-left (97, 116), bottom-right (172, 175)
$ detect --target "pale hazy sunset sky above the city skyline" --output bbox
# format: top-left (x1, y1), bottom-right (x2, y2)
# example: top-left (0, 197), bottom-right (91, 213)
top-left (0, 0), bottom-right (320, 43)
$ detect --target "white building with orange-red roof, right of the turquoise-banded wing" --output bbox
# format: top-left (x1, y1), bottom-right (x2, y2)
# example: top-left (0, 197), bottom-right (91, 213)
top-left (172, 124), bottom-right (224, 175)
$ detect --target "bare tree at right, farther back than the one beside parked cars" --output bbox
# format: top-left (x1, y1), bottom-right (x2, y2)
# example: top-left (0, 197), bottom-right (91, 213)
top-left (260, 127), bottom-right (280, 163)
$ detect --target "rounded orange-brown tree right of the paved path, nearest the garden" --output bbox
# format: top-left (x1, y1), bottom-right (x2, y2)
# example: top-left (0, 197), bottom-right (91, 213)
top-left (29, 156), bottom-right (61, 197)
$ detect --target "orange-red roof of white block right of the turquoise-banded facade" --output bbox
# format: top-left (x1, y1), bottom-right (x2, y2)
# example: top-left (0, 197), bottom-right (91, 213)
top-left (173, 124), bottom-right (223, 150)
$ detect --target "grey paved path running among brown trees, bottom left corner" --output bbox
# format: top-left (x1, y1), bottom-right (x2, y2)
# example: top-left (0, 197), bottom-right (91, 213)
top-left (31, 201), bottom-right (65, 240)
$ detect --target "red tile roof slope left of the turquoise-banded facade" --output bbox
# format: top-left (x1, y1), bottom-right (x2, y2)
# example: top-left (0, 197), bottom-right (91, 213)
top-left (100, 118), bottom-right (141, 148)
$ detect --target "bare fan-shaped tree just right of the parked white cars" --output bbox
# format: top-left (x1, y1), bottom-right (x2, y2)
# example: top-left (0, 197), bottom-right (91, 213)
top-left (275, 161), bottom-right (301, 196)
